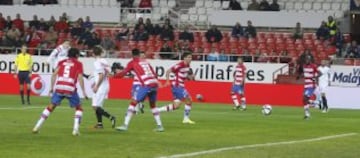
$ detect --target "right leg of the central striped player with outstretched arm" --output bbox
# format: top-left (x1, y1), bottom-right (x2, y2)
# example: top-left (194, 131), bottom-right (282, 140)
top-left (148, 88), bottom-right (165, 132)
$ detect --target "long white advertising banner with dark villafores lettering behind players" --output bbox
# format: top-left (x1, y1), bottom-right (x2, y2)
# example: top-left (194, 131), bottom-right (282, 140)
top-left (0, 55), bottom-right (289, 83)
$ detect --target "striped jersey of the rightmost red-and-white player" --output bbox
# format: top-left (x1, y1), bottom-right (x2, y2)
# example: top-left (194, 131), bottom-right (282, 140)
top-left (303, 64), bottom-right (318, 88)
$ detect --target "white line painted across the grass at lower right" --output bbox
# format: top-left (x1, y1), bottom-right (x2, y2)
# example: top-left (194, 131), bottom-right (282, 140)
top-left (159, 133), bottom-right (357, 158)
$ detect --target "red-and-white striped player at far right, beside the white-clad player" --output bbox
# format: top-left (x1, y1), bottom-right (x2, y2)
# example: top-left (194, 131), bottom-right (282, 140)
top-left (299, 56), bottom-right (318, 119)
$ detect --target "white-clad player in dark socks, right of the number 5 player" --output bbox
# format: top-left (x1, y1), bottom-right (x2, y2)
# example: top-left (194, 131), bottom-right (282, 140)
top-left (92, 46), bottom-right (116, 129)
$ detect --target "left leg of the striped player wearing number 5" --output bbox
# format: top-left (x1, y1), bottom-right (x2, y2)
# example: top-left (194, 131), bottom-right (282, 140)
top-left (33, 93), bottom-right (64, 133)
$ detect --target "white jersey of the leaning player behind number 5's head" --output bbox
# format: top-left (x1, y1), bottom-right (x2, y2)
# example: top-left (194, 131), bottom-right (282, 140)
top-left (46, 45), bottom-right (69, 68)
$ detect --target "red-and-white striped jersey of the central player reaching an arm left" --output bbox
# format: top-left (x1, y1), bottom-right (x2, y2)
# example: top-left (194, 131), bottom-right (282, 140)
top-left (114, 57), bottom-right (158, 87)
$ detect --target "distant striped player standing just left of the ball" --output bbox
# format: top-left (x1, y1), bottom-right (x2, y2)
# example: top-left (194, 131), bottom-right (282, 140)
top-left (230, 57), bottom-right (246, 111)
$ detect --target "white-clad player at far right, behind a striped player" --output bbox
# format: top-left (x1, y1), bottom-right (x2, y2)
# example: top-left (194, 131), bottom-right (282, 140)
top-left (317, 60), bottom-right (331, 113)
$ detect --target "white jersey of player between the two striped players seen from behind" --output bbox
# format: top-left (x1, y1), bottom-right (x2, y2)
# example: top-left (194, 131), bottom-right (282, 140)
top-left (94, 58), bottom-right (111, 93)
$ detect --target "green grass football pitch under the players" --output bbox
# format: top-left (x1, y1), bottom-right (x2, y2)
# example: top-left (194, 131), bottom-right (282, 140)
top-left (0, 95), bottom-right (360, 158)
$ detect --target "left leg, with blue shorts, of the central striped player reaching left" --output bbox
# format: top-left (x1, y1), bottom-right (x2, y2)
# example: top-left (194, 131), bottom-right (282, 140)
top-left (115, 86), bottom-right (149, 131)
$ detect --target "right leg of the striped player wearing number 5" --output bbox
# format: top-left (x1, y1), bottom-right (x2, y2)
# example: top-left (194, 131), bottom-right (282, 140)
top-left (67, 92), bottom-right (83, 136)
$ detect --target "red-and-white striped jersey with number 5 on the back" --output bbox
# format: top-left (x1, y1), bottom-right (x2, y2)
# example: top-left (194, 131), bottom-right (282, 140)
top-left (54, 58), bottom-right (83, 95)
